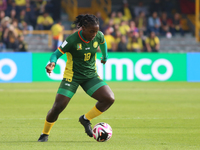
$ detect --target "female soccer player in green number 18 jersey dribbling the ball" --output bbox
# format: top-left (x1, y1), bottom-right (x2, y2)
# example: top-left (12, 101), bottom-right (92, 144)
top-left (38, 15), bottom-right (114, 142)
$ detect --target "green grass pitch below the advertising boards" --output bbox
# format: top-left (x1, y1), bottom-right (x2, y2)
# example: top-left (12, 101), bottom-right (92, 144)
top-left (0, 82), bottom-right (200, 150)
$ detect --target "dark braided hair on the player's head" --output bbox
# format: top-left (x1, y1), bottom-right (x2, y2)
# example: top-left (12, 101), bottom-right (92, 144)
top-left (74, 14), bottom-right (99, 28)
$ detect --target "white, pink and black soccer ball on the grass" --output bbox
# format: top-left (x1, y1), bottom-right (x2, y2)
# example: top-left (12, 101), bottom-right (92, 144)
top-left (92, 122), bottom-right (112, 142)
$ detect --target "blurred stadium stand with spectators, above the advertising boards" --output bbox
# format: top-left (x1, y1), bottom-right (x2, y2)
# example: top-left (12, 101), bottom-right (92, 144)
top-left (0, 0), bottom-right (200, 52)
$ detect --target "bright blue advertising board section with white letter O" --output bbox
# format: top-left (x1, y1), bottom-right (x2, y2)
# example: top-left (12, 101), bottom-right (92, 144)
top-left (0, 53), bottom-right (32, 82)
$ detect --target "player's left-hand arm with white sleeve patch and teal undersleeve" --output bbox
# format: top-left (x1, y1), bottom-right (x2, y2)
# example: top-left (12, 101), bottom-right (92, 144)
top-left (45, 40), bottom-right (71, 75)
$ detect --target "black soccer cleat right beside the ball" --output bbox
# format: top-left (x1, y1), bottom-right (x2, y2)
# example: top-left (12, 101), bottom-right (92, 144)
top-left (79, 115), bottom-right (93, 137)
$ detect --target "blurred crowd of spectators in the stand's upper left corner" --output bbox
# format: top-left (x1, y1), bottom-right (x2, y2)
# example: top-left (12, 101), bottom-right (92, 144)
top-left (0, 0), bottom-right (60, 52)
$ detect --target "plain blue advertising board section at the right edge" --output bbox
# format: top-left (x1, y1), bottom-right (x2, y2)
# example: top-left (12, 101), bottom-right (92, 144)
top-left (186, 53), bottom-right (200, 82)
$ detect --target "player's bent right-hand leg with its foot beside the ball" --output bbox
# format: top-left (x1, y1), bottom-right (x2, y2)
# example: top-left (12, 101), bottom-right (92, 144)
top-left (79, 77), bottom-right (114, 137)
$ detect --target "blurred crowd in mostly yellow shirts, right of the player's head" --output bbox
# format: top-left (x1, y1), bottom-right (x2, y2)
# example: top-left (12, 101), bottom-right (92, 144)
top-left (96, 0), bottom-right (184, 52)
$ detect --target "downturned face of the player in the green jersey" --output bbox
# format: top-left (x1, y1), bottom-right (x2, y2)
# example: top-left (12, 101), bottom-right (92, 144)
top-left (82, 25), bottom-right (99, 41)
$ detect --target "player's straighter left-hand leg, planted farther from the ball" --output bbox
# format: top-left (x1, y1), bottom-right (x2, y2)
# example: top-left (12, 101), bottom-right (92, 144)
top-left (38, 79), bottom-right (79, 142)
